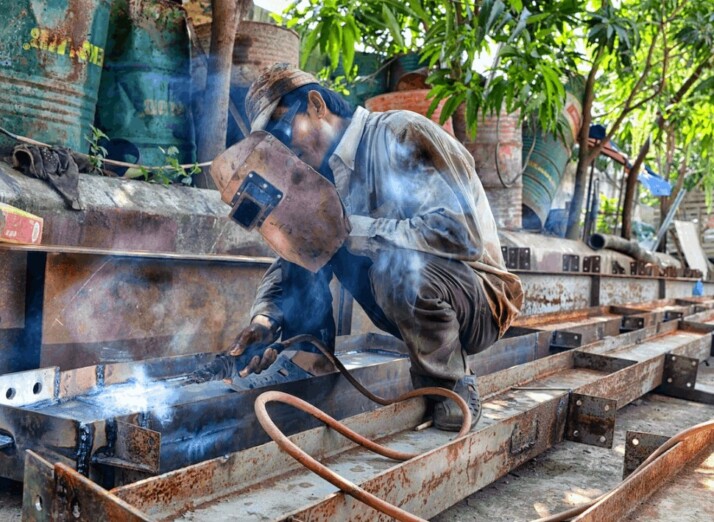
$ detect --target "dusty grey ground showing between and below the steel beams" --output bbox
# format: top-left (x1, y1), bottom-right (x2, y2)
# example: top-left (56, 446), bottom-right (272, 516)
top-left (0, 358), bottom-right (714, 522)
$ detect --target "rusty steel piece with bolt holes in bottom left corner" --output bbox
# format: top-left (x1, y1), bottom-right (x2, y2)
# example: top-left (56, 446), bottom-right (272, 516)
top-left (22, 450), bottom-right (151, 522)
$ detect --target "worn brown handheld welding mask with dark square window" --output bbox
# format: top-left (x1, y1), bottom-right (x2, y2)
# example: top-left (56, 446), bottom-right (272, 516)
top-left (211, 131), bottom-right (350, 272)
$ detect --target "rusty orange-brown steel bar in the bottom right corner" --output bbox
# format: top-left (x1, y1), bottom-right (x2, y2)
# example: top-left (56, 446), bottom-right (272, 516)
top-left (573, 424), bottom-right (714, 522)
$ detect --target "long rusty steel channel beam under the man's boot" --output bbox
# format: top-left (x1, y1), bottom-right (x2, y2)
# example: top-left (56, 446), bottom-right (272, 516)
top-left (22, 314), bottom-right (711, 520)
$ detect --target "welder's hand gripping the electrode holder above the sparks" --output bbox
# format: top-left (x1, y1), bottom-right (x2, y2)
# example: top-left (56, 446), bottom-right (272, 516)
top-left (228, 315), bottom-right (280, 377)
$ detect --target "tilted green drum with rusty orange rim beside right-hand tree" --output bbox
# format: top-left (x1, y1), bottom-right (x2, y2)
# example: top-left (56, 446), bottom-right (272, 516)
top-left (523, 78), bottom-right (584, 230)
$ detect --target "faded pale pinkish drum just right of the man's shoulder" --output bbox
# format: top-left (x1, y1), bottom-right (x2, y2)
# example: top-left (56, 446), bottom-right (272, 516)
top-left (454, 106), bottom-right (523, 229)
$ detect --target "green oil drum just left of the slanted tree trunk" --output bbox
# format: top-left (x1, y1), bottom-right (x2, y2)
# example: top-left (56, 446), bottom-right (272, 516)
top-left (96, 0), bottom-right (196, 166)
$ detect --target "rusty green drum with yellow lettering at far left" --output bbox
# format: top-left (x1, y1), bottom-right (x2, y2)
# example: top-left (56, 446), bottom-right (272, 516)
top-left (0, 0), bottom-right (111, 152)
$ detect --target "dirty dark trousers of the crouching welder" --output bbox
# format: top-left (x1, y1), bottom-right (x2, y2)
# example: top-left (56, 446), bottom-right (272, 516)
top-left (282, 247), bottom-right (499, 387)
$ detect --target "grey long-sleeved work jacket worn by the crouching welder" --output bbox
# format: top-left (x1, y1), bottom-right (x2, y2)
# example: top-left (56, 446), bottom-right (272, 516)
top-left (251, 107), bottom-right (523, 335)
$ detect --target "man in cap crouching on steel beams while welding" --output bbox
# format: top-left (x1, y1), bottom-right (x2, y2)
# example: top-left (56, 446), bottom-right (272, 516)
top-left (212, 64), bottom-right (523, 431)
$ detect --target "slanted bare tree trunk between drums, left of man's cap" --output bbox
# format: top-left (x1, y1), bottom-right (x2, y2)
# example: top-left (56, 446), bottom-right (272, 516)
top-left (196, 0), bottom-right (252, 188)
